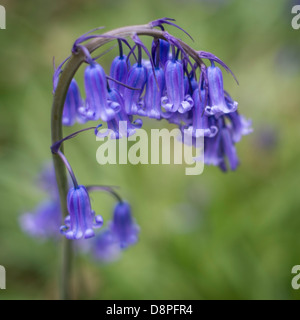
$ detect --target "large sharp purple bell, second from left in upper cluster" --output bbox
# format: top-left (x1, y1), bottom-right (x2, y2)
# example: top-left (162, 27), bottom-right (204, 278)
top-left (84, 63), bottom-right (117, 122)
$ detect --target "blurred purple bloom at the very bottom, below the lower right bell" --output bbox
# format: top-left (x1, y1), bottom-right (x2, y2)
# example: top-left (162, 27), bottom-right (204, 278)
top-left (91, 229), bottom-right (121, 262)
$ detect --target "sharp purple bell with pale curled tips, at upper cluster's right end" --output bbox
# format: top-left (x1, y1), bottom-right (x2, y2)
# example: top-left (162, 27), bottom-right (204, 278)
top-left (205, 62), bottom-right (238, 116)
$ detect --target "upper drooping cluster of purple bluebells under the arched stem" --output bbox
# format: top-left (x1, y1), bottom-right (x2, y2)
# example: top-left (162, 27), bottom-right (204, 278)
top-left (54, 19), bottom-right (252, 171)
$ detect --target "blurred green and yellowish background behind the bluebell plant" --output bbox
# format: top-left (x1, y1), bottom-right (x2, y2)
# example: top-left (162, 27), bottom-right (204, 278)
top-left (0, 0), bottom-right (300, 299)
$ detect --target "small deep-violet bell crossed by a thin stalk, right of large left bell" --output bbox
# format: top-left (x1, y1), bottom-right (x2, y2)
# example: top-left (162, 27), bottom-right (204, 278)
top-left (109, 55), bottom-right (130, 95)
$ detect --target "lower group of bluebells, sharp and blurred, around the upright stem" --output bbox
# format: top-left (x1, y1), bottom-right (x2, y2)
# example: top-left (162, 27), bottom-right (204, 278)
top-left (20, 166), bottom-right (139, 261)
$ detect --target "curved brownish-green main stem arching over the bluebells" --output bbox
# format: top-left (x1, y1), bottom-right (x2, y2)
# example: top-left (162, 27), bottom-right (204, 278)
top-left (51, 25), bottom-right (203, 300)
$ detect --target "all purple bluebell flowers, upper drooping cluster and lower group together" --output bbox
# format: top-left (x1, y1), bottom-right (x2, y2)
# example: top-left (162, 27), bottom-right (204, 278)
top-left (21, 18), bottom-right (252, 260)
